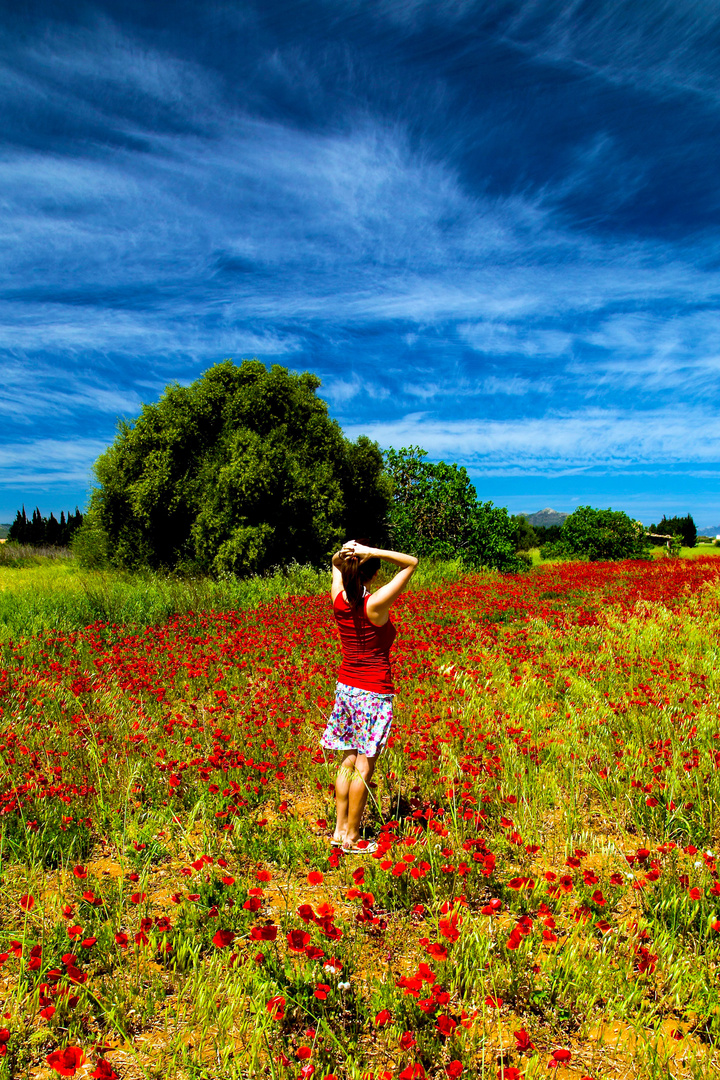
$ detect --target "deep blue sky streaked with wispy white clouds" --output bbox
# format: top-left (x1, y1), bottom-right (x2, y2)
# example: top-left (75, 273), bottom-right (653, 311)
top-left (0, 0), bottom-right (720, 526)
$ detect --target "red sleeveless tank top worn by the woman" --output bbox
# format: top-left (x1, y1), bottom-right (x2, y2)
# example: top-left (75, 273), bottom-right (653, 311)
top-left (332, 592), bottom-right (397, 693)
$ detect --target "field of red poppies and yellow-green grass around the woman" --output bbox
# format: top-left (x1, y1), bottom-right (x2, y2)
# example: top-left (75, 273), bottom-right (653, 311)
top-left (0, 557), bottom-right (720, 1080)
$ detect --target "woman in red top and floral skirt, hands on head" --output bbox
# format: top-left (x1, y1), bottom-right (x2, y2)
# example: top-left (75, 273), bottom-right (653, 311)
top-left (321, 540), bottom-right (418, 853)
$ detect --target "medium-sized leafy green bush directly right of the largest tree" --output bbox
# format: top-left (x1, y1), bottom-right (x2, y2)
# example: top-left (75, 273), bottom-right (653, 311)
top-left (385, 446), bottom-right (526, 571)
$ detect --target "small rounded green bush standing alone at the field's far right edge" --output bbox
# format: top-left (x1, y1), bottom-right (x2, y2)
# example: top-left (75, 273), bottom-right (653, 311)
top-left (541, 507), bottom-right (650, 563)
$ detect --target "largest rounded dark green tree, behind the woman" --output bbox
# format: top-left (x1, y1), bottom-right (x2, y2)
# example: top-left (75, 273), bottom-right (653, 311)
top-left (86, 360), bottom-right (390, 575)
